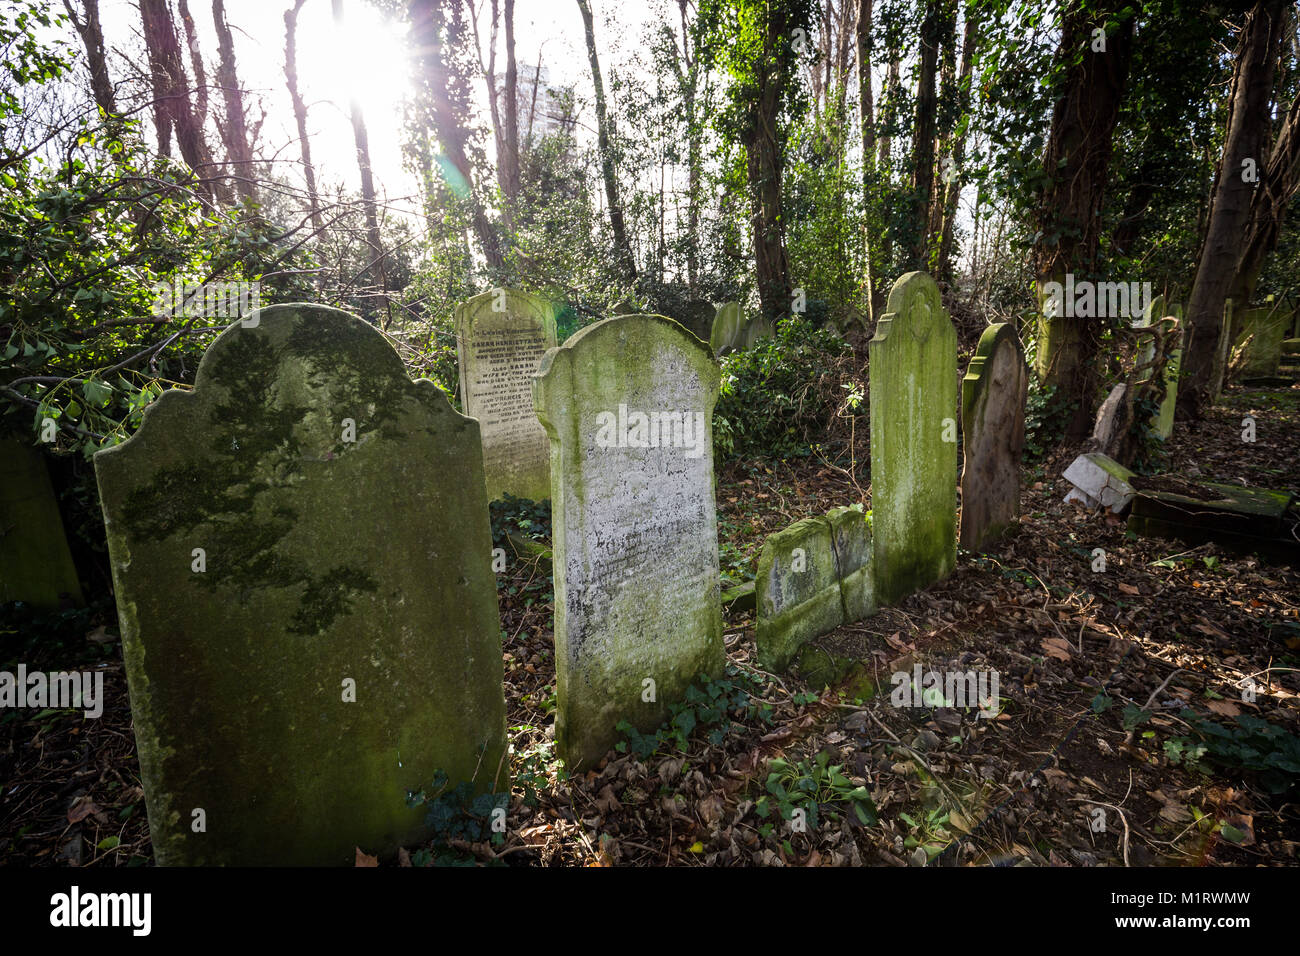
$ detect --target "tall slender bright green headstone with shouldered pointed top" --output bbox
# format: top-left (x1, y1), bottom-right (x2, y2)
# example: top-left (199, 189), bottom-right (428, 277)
top-left (868, 272), bottom-right (957, 605)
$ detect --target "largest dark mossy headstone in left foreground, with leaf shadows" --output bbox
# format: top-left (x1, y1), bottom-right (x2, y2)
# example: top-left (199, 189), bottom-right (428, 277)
top-left (95, 304), bottom-right (504, 865)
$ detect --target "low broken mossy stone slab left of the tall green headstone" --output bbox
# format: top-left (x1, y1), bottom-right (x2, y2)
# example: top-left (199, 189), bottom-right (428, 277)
top-left (754, 507), bottom-right (876, 671)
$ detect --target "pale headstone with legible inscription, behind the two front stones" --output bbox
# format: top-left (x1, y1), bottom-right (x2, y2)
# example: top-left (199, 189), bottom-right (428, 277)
top-left (456, 289), bottom-right (555, 501)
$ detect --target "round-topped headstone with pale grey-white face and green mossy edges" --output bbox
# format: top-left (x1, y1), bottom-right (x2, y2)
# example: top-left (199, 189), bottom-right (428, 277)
top-left (533, 315), bottom-right (724, 767)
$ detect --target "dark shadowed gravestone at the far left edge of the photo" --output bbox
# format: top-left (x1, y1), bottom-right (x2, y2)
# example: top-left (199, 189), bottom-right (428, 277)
top-left (0, 438), bottom-right (83, 610)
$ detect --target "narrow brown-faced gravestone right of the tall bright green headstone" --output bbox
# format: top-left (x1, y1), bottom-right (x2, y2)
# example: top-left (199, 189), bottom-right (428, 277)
top-left (961, 323), bottom-right (1030, 551)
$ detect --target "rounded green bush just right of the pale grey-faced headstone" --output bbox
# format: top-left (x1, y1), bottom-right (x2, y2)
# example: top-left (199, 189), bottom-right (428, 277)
top-left (714, 319), bottom-right (852, 458)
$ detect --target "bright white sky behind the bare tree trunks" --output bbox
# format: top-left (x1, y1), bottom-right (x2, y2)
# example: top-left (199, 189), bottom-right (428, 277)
top-left (100, 0), bottom-right (659, 213)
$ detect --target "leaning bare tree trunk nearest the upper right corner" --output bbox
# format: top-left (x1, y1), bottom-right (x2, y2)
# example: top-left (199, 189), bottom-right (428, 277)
top-left (1180, 0), bottom-right (1286, 416)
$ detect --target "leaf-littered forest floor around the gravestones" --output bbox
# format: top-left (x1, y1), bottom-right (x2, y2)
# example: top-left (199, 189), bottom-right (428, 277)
top-left (0, 386), bottom-right (1300, 866)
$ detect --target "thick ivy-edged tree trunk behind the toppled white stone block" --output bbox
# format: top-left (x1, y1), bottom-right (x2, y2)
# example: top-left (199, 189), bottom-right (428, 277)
top-left (1034, 0), bottom-right (1134, 441)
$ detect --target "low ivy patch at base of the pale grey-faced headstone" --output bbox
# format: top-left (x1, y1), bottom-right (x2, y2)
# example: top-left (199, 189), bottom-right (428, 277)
top-left (615, 665), bottom-right (772, 760)
